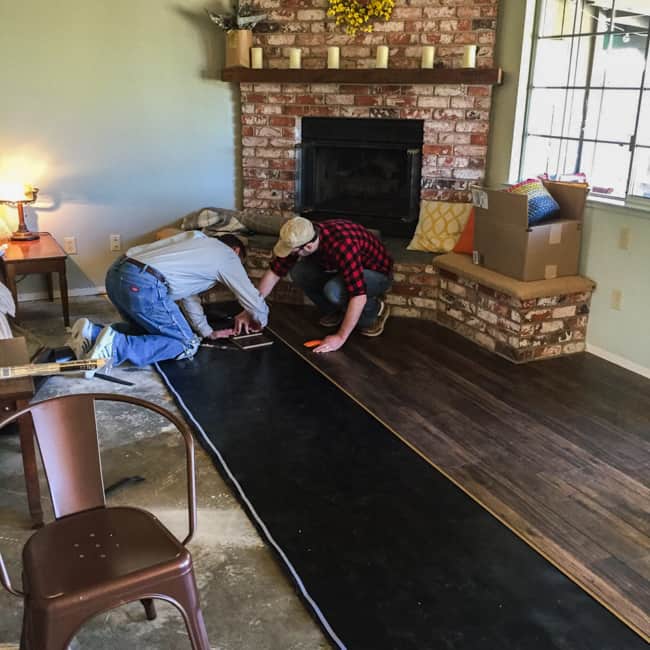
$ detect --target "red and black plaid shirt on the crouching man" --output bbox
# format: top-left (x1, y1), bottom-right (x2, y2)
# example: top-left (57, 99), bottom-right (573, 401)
top-left (270, 219), bottom-right (393, 296)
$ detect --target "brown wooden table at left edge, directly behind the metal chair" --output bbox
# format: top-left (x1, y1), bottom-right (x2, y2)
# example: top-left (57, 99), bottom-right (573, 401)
top-left (0, 337), bottom-right (43, 528)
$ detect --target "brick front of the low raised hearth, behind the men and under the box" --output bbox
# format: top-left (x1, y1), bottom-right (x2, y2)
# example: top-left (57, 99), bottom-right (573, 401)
top-left (203, 243), bottom-right (593, 363)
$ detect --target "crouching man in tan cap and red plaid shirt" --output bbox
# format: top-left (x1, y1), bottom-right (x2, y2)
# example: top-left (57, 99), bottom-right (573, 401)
top-left (259, 217), bottom-right (393, 352)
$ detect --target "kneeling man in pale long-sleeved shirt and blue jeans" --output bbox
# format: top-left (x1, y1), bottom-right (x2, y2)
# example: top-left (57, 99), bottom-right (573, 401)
top-left (67, 231), bottom-right (269, 366)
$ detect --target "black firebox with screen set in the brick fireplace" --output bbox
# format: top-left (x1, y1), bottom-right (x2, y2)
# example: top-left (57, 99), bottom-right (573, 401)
top-left (296, 117), bottom-right (424, 236)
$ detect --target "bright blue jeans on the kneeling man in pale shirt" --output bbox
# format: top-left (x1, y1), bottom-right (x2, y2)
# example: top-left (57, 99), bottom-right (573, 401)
top-left (106, 260), bottom-right (200, 366)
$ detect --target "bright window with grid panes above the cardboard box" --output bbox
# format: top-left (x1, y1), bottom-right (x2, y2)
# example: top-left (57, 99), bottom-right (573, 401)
top-left (520, 0), bottom-right (650, 203)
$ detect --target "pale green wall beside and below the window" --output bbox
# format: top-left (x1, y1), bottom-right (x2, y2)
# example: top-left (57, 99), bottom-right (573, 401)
top-left (487, 0), bottom-right (650, 377)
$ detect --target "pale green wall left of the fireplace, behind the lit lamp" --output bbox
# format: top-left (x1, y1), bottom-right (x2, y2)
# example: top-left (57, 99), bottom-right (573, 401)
top-left (0, 0), bottom-right (233, 293)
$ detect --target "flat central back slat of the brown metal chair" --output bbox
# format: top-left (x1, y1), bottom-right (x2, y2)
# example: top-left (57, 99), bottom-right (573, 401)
top-left (31, 395), bottom-right (106, 519)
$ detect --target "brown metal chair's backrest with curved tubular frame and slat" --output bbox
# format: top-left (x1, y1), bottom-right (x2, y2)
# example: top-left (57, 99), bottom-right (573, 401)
top-left (0, 393), bottom-right (196, 545)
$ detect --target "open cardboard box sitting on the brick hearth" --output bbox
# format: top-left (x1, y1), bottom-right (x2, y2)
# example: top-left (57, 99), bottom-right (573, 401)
top-left (472, 181), bottom-right (588, 282)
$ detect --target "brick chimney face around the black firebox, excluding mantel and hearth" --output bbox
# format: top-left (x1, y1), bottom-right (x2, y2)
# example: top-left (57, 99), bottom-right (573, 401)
top-left (240, 0), bottom-right (498, 213)
